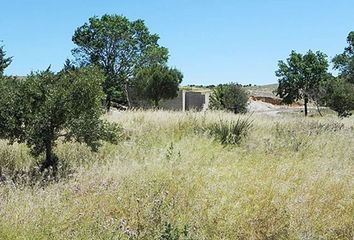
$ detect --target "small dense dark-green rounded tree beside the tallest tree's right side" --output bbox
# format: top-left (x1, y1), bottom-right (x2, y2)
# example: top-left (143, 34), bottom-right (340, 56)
top-left (135, 65), bottom-right (183, 107)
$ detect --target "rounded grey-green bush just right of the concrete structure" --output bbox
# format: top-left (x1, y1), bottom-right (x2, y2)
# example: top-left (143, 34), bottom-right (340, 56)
top-left (210, 83), bottom-right (249, 114)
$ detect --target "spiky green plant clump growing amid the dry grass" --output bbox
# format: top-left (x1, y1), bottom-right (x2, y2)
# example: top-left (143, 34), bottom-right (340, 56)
top-left (208, 118), bottom-right (252, 145)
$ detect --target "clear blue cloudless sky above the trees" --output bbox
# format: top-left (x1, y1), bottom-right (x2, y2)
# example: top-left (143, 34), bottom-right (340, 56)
top-left (0, 0), bottom-right (354, 85)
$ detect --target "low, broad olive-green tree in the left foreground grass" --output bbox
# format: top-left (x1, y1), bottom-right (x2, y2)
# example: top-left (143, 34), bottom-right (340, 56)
top-left (0, 67), bottom-right (117, 173)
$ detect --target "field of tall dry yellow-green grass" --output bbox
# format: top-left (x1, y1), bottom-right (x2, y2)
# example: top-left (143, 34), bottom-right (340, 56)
top-left (0, 111), bottom-right (354, 240)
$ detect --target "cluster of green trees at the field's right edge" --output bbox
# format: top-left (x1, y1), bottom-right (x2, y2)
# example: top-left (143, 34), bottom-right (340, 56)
top-left (276, 31), bottom-right (354, 117)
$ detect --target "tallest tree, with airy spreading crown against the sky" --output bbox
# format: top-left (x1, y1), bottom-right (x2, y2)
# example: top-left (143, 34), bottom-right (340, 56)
top-left (72, 15), bottom-right (168, 110)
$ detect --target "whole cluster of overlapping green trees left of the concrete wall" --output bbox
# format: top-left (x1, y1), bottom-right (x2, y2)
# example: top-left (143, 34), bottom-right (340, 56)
top-left (0, 15), bottom-right (183, 173)
